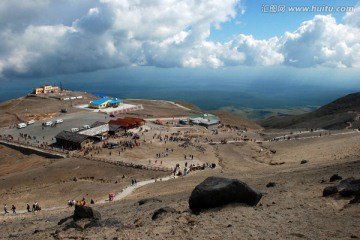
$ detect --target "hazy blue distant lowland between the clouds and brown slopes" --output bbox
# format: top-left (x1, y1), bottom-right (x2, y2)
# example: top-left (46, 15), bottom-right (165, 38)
top-left (0, 67), bottom-right (360, 119)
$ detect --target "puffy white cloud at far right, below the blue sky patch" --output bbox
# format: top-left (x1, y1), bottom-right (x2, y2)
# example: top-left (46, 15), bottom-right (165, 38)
top-left (280, 15), bottom-right (360, 67)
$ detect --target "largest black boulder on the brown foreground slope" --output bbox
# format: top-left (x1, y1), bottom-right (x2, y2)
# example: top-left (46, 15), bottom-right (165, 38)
top-left (189, 177), bottom-right (262, 212)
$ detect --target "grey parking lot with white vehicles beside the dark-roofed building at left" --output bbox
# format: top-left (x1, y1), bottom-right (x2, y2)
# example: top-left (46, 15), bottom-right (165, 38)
top-left (1, 111), bottom-right (115, 145)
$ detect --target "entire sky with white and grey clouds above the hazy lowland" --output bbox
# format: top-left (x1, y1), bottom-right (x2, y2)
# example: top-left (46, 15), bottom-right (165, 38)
top-left (0, 0), bottom-right (360, 79)
